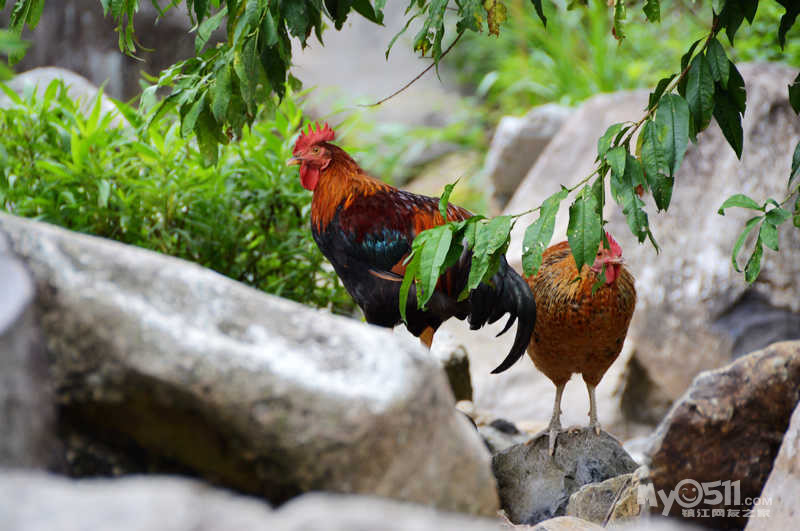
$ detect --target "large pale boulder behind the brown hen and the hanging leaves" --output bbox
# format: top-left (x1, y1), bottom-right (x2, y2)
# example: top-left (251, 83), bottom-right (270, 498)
top-left (500, 64), bottom-right (800, 423)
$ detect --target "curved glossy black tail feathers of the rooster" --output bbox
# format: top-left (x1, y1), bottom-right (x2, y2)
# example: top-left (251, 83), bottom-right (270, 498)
top-left (469, 258), bottom-right (536, 374)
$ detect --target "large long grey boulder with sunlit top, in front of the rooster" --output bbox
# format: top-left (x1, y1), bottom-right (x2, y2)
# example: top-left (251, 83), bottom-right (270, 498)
top-left (0, 214), bottom-right (498, 514)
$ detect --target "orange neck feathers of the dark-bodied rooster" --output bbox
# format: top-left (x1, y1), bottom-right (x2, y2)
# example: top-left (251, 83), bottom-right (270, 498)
top-left (311, 144), bottom-right (395, 232)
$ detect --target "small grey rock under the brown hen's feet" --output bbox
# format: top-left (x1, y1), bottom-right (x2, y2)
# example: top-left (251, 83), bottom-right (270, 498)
top-left (492, 428), bottom-right (637, 525)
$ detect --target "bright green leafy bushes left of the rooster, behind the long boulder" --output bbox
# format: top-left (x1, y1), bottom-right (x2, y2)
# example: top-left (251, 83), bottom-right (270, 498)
top-left (0, 82), bottom-right (352, 311)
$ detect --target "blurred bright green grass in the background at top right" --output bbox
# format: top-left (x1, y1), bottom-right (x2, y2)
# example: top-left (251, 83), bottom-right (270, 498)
top-left (448, 0), bottom-right (703, 114)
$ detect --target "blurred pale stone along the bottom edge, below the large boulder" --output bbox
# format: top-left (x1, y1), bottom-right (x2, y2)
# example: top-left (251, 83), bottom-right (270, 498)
top-left (0, 469), bottom-right (510, 531)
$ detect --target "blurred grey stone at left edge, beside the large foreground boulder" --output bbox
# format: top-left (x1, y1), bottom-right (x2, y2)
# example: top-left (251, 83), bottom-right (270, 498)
top-left (0, 231), bottom-right (57, 468)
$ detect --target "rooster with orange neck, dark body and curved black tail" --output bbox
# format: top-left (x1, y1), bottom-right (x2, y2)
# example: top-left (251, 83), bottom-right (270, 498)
top-left (287, 124), bottom-right (536, 370)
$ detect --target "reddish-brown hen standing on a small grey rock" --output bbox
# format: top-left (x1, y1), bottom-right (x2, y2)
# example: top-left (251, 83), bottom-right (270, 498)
top-left (526, 232), bottom-right (636, 455)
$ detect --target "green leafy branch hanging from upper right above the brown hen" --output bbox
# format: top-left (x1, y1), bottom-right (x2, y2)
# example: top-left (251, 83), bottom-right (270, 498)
top-left (400, 0), bottom-right (800, 304)
